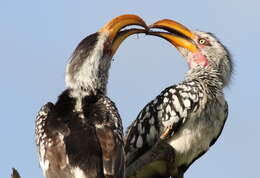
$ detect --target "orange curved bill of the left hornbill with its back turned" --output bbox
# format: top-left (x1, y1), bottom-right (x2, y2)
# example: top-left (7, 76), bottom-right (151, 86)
top-left (99, 14), bottom-right (148, 54)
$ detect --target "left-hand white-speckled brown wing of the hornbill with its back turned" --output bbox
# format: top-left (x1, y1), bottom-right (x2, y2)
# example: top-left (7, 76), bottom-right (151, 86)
top-left (35, 102), bottom-right (76, 178)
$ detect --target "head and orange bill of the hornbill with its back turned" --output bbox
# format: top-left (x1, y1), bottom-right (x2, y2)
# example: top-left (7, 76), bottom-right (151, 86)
top-left (65, 14), bottom-right (148, 92)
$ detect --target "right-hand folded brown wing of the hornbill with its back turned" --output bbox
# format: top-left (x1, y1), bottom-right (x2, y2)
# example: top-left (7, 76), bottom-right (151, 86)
top-left (94, 96), bottom-right (125, 178)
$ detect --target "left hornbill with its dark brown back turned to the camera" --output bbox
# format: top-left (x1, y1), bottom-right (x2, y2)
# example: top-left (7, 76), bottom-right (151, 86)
top-left (36, 15), bottom-right (146, 178)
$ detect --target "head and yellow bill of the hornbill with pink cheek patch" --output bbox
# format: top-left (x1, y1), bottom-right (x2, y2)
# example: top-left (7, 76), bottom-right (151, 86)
top-left (148, 19), bottom-right (232, 85)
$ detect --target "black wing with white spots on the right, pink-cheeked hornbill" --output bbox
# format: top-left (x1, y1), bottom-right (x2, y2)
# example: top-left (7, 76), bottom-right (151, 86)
top-left (125, 81), bottom-right (205, 165)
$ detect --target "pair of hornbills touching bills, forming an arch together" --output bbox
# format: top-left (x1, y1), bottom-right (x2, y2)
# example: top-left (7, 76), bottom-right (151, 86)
top-left (35, 14), bottom-right (232, 178)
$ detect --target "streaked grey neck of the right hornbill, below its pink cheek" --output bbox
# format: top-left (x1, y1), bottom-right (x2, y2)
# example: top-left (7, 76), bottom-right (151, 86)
top-left (185, 67), bottom-right (224, 98)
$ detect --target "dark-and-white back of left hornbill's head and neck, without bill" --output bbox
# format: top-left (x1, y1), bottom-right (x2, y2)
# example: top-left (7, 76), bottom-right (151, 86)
top-left (65, 32), bottom-right (111, 97)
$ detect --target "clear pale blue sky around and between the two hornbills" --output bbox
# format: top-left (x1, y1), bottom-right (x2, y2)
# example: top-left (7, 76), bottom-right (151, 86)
top-left (0, 0), bottom-right (260, 178)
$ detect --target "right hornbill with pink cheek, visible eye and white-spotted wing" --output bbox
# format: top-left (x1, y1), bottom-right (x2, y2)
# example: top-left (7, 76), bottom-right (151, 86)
top-left (125, 19), bottom-right (232, 178)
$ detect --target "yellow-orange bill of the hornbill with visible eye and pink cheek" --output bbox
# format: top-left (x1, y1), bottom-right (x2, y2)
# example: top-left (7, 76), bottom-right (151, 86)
top-left (148, 19), bottom-right (198, 52)
